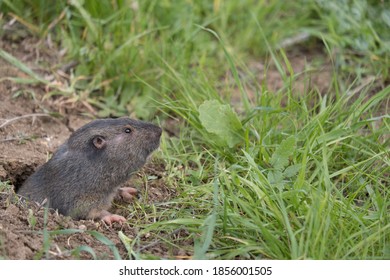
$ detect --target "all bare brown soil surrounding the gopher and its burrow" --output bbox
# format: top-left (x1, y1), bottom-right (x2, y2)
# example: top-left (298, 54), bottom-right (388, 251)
top-left (0, 34), bottom-right (177, 259)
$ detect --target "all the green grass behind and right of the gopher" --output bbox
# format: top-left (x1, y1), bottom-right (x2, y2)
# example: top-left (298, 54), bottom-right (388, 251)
top-left (0, 0), bottom-right (390, 259)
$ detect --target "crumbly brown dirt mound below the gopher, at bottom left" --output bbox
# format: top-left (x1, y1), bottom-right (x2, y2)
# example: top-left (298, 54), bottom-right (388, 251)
top-left (0, 163), bottom-right (170, 259)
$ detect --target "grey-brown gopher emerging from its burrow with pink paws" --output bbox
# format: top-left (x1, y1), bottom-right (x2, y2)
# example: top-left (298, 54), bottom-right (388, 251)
top-left (18, 118), bottom-right (162, 224)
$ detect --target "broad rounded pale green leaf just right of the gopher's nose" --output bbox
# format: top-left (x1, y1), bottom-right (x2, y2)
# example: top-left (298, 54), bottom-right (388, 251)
top-left (199, 100), bottom-right (242, 148)
